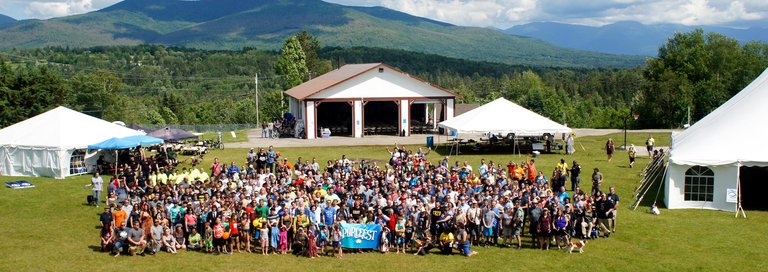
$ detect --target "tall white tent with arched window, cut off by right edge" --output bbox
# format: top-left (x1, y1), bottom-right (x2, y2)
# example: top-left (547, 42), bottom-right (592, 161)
top-left (665, 67), bottom-right (768, 211)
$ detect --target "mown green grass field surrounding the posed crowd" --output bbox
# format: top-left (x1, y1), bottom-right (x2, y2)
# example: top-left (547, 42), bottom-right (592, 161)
top-left (0, 131), bottom-right (768, 271)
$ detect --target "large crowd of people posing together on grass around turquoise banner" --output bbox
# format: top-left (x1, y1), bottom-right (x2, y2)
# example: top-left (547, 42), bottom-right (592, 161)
top-left (92, 145), bottom-right (619, 258)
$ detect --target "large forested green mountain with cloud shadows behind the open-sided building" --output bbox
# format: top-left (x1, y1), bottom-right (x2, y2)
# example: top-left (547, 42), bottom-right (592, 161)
top-left (0, 0), bottom-right (644, 68)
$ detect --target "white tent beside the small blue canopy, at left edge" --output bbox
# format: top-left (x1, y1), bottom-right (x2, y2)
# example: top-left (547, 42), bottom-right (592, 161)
top-left (0, 107), bottom-right (144, 178)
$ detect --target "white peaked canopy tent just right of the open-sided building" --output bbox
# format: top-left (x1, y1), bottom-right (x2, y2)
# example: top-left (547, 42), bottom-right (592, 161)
top-left (439, 98), bottom-right (571, 136)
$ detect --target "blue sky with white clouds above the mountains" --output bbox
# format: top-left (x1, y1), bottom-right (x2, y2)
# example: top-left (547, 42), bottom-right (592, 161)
top-left (0, 0), bottom-right (768, 28)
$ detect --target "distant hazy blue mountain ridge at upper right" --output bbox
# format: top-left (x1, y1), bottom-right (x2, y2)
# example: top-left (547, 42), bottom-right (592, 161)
top-left (503, 21), bottom-right (768, 56)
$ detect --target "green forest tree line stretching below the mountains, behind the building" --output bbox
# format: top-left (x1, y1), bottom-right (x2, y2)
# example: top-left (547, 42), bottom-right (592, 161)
top-left (0, 30), bottom-right (768, 128)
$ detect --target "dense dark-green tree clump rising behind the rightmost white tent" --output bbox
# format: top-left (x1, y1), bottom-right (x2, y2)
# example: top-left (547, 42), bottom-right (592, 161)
top-left (638, 29), bottom-right (768, 127)
